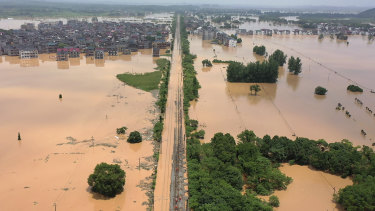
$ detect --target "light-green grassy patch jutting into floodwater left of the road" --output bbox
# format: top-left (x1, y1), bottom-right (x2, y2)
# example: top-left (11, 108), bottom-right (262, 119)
top-left (116, 71), bottom-right (162, 92)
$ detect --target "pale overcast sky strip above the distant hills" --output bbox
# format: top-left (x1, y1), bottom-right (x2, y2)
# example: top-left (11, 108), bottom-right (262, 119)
top-left (68, 0), bottom-right (375, 7)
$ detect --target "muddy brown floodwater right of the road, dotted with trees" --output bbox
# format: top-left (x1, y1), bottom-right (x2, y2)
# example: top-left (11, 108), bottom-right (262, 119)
top-left (189, 35), bottom-right (375, 210)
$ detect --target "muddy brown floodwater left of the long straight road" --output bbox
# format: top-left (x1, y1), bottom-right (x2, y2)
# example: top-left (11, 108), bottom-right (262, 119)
top-left (0, 50), bottom-right (169, 210)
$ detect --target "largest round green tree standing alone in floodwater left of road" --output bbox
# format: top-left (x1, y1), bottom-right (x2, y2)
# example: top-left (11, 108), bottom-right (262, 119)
top-left (87, 163), bottom-right (125, 197)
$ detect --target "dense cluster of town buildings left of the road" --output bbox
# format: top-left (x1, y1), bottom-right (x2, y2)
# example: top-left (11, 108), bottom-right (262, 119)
top-left (0, 18), bottom-right (170, 61)
